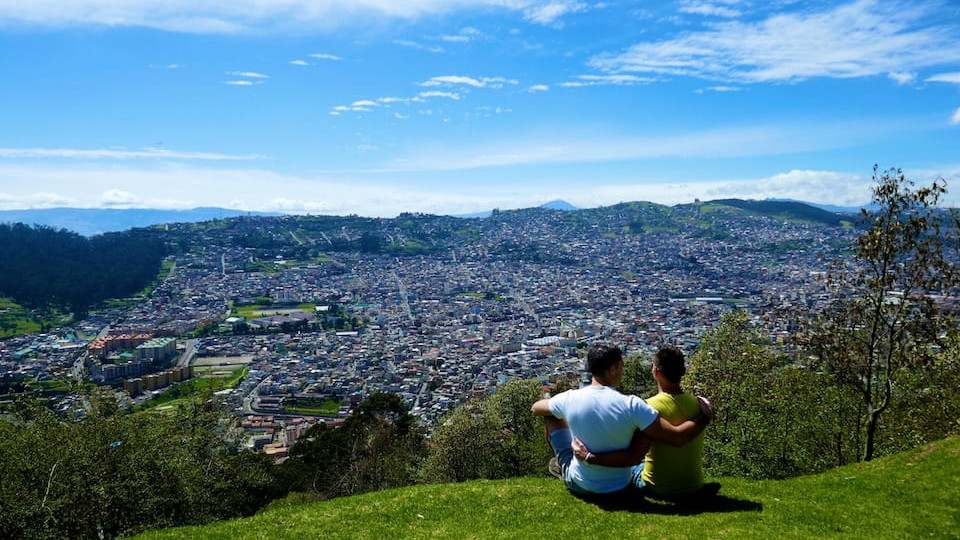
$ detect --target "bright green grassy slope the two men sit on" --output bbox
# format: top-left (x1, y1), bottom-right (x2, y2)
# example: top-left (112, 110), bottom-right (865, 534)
top-left (141, 438), bottom-right (960, 539)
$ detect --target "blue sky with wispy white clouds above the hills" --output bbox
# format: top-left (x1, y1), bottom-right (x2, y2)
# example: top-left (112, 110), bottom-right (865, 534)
top-left (0, 0), bottom-right (960, 216)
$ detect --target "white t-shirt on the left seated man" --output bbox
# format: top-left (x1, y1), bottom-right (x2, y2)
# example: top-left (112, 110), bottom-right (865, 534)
top-left (550, 385), bottom-right (657, 493)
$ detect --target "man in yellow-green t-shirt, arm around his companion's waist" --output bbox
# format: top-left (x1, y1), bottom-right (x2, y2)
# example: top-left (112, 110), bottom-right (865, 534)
top-left (574, 347), bottom-right (704, 496)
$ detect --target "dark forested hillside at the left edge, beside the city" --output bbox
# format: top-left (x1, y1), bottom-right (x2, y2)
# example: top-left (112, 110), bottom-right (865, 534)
top-left (0, 223), bottom-right (165, 314)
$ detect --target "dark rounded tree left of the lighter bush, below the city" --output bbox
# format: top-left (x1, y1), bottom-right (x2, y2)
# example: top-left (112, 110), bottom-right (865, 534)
top-left (280, 394), bottom-right (424, 498)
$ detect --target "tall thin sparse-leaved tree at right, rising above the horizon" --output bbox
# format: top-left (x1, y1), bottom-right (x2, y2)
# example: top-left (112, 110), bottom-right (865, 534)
top-left (806, 166), bottom-right (955, 461)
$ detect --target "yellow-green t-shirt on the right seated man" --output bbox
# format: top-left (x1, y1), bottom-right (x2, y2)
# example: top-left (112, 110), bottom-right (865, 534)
top-left (643, 392), bottom-right (703, 494)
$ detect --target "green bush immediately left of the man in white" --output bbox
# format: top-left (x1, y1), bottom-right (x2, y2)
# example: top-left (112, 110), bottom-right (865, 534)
top-left (422, 380), bottom-right (552, 482)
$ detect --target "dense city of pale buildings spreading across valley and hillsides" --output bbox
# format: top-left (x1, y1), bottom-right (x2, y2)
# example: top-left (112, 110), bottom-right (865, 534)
top-left (0, 198), bottom-right (856, 459)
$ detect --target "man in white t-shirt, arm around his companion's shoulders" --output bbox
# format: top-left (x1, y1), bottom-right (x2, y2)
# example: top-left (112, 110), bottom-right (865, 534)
top-left (531, 345), bottom-right (710, 495)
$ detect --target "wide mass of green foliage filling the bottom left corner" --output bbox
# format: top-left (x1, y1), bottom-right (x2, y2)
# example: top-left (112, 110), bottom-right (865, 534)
top-left (0, 399), bottom-right (279, 538)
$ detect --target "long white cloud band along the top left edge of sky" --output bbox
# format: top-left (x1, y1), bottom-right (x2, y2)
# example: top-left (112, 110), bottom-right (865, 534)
top-left (0, 0), bottom-right (590, 34)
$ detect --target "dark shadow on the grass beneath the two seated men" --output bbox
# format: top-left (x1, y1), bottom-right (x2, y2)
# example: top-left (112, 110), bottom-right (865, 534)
top-left (575, 484), bottom-right (763, 516)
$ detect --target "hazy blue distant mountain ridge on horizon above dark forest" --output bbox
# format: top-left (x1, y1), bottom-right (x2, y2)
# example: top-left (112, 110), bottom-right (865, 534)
top-left (0, 208), bottom-right (278, 236)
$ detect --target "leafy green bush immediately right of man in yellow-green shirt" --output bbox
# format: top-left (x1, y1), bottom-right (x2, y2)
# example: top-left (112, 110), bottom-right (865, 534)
top-left (684, 312), bottom-right (849, 478)
